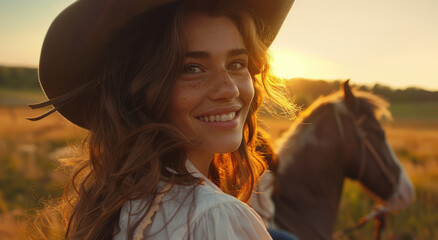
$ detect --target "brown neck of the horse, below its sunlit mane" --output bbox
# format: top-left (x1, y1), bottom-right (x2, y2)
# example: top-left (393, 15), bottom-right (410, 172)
top-left (276, 108), bottom-right (344, 239)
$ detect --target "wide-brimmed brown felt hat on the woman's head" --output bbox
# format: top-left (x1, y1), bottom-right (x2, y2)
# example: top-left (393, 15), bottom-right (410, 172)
top-left (30, 0), bottom-right (294, 128)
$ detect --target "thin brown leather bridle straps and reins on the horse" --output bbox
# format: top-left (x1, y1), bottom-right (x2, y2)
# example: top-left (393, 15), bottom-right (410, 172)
top-left (333, 103), bottom-right (395, 240)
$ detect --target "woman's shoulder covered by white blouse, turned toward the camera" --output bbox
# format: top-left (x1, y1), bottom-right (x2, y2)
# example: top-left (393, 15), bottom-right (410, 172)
top-left (155, 181), bottom-right (271, 239)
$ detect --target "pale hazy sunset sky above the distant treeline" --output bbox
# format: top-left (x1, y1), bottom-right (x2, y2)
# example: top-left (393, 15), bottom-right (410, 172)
top-left (0, 0), bottom-right (438, 90)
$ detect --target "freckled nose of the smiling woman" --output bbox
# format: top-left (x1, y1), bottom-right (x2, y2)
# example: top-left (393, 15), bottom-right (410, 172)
top-left (210, 71), bottom-right (240, 100)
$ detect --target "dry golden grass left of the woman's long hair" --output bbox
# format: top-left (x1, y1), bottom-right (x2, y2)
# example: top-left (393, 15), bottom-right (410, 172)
top-left (0, 107), bottom-right (87, 240)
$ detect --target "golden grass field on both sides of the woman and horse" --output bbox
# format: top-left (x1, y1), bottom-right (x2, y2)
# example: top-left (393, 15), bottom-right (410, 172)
top-left (0, 87), bottom-right (438, 240)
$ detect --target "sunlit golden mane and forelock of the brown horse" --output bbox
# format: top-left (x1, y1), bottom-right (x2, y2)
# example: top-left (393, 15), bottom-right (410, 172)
top-left (275, 88), bottom-right (392, 150)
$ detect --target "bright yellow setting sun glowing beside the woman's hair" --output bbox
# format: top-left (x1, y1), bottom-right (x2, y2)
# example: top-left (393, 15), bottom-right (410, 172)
top-left (271, 48), bottom-right (305, 79)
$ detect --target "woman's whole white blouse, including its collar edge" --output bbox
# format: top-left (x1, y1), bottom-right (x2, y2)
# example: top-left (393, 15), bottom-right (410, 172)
top-left (113, 161), bottom-right (272, 240)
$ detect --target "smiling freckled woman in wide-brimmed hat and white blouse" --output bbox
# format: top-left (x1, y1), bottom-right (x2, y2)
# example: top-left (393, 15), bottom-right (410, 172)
top-left (29, 0), bottom-right (293, 239)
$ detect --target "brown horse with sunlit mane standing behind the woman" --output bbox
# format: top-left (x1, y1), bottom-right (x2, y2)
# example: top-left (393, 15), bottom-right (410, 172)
top-left (252, 80), bottom-right (414, 240)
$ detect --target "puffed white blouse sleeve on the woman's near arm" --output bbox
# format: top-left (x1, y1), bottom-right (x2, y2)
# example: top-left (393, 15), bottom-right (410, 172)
top-left (190, 201), bottom-right (272, 240)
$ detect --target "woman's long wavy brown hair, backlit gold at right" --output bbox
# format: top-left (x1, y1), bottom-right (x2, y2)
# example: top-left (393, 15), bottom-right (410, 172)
top-left (32, 0), bottom-right (290, 239)
